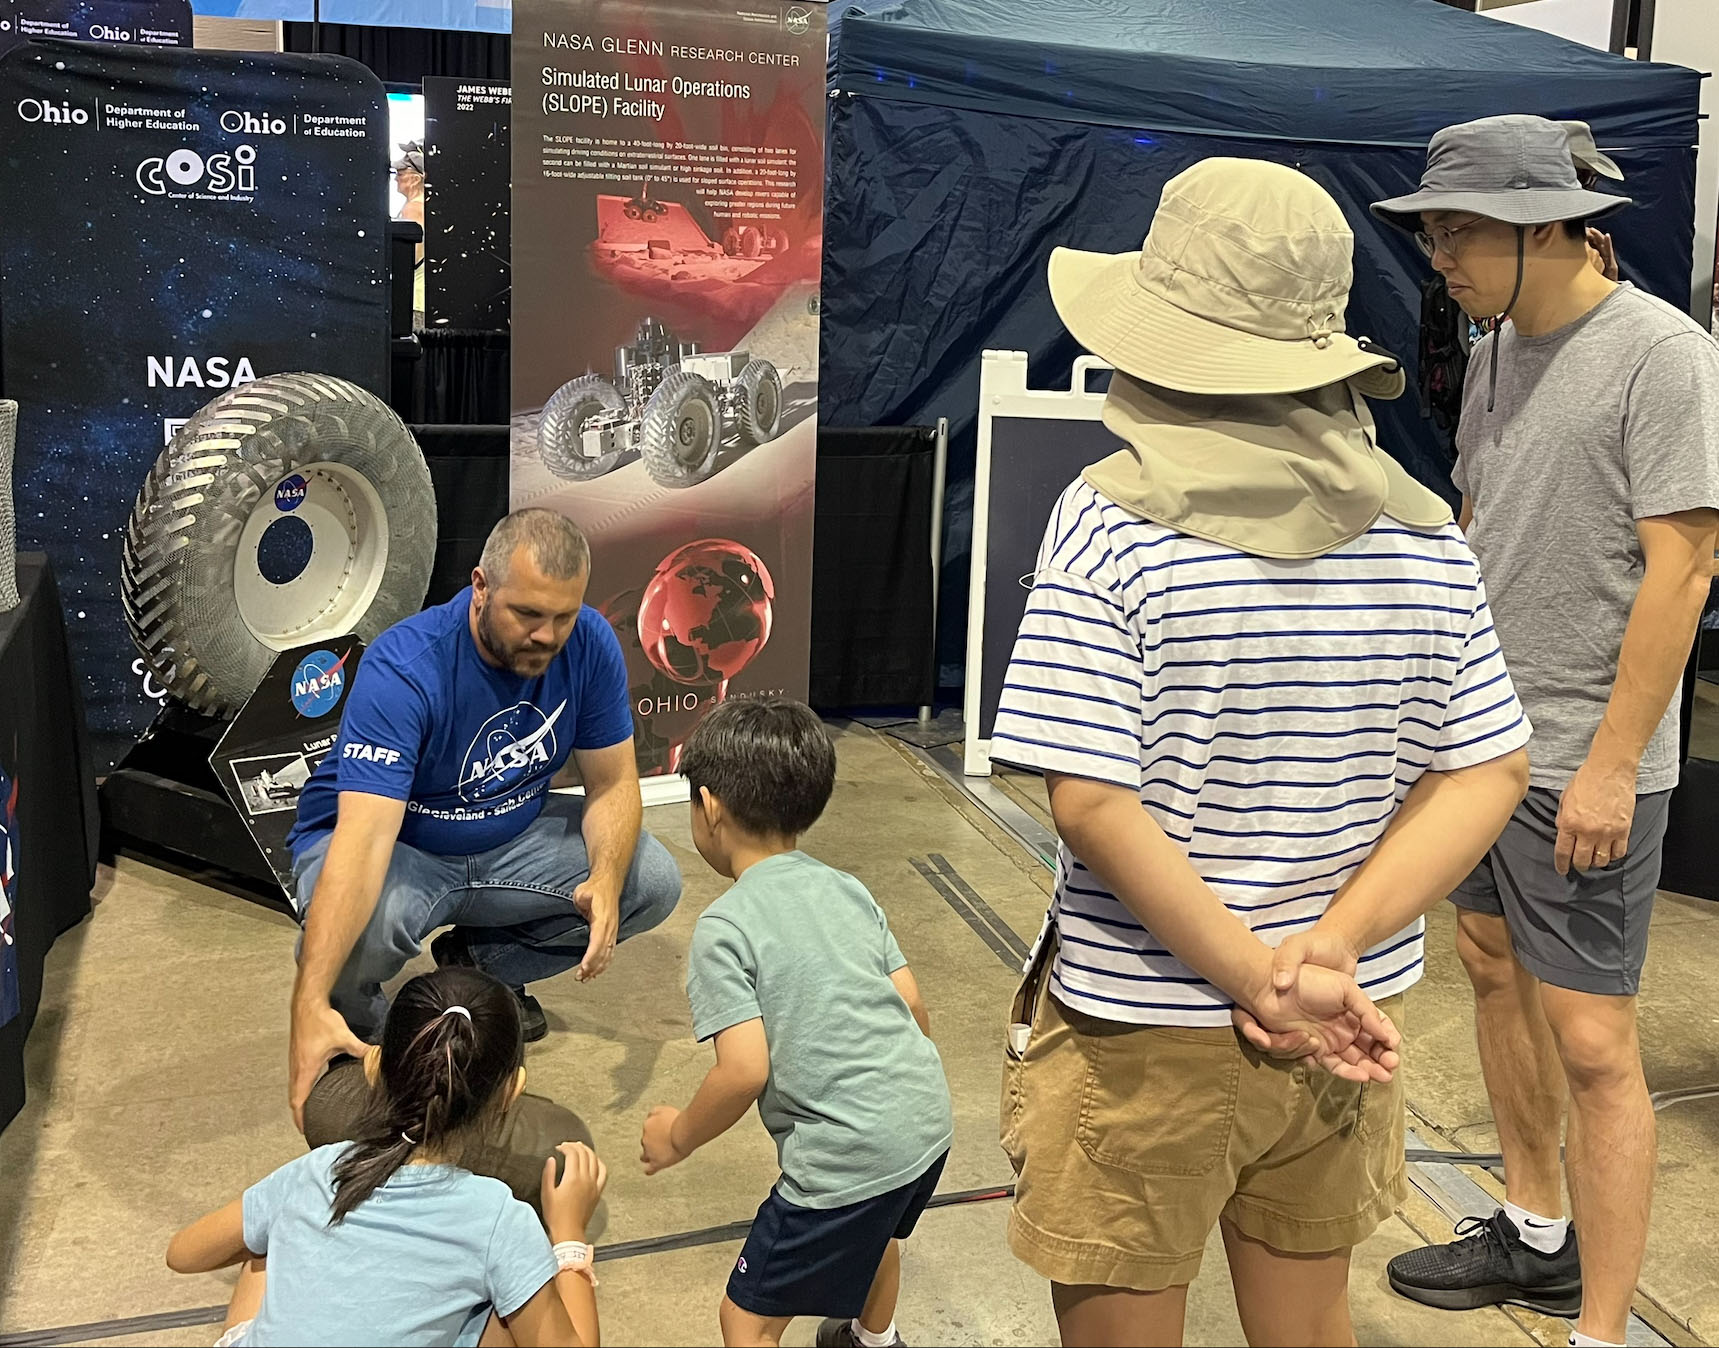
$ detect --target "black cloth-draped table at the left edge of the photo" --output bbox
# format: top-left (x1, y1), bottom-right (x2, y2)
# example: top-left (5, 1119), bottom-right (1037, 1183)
top-left (0, 554), bottom-right (96, 1128)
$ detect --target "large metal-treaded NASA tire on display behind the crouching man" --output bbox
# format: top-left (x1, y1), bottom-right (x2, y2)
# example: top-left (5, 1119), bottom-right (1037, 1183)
top-left (120, 375), bottom-right (437, 715)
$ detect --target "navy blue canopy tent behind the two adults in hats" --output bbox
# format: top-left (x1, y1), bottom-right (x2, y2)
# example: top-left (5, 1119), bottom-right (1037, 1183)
top-left (820, 0), bottom-right (1700, 684)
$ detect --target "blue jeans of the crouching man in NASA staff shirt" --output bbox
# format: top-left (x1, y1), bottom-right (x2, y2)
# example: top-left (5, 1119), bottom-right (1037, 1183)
top-left (294, 796), bottom-right (681, 1040)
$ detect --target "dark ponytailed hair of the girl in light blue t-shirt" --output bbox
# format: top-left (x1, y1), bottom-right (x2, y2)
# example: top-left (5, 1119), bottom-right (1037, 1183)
top-left (328, 968), bottom-right (524, 1226)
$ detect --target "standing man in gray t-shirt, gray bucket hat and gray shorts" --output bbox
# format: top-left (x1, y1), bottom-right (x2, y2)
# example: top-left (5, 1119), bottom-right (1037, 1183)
top-left (1373, 117), bottom-right (1719, 1345)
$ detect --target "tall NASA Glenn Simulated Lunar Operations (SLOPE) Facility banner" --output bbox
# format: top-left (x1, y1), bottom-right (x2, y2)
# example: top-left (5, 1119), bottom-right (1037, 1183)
top-left (511, 0), bottom-right (825, 774)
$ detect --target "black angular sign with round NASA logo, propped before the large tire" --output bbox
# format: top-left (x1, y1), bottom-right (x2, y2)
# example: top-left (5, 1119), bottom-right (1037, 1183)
top-left (210, 636), bottom-right (364, 899)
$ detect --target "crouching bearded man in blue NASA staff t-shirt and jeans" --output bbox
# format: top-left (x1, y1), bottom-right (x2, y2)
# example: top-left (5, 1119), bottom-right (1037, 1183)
top-left (287, 511), bottom-right (681, 1126)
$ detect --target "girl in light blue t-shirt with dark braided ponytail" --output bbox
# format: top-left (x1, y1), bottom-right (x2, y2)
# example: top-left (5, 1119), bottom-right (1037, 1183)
top-left (167, 968), bottom-right (609, 1345)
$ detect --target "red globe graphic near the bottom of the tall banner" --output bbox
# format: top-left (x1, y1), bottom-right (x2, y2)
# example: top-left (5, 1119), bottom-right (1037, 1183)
top-left (639, 538), bottom-right (775, 684)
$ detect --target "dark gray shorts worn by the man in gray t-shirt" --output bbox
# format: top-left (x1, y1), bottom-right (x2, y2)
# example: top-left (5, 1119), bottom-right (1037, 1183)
top-left (1451, 786), bottom-right (1671, 997)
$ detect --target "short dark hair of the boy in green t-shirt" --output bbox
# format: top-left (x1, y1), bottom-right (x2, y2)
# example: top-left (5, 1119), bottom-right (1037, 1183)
top-left (681, 698), bottom-right (835, 836)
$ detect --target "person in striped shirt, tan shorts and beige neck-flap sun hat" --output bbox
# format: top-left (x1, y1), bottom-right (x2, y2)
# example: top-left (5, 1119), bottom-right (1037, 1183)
top-left (990, 160), bottom-right (1530, 1345)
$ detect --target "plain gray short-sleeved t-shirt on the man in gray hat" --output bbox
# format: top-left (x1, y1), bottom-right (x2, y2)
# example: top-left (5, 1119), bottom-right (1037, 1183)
top-left (1451, 285), bottom-right (1719, 794)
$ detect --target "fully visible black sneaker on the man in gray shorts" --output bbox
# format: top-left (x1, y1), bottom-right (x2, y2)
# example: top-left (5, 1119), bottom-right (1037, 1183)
top-left (1386, 1209), bottom-right (1581, 1315)
